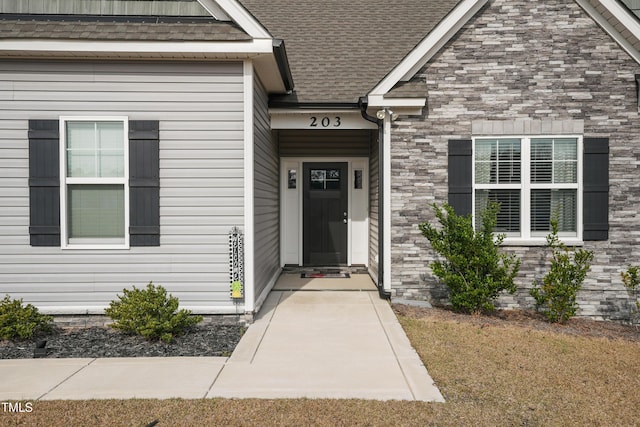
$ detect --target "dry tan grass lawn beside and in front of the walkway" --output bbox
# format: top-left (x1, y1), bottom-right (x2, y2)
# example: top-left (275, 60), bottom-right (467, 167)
top-left (0, 315), bottom-right (640, 427)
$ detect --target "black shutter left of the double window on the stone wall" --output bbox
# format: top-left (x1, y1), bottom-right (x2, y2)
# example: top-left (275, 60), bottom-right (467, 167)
top-left (449, 139), bottom-right (473, 215)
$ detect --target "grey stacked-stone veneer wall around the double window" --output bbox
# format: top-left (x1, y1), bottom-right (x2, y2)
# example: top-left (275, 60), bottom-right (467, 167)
top-left (391, 0), bottom-right (640, 319)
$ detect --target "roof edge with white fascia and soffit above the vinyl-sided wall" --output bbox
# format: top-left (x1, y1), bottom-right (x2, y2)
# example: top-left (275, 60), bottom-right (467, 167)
top-left (0, 0), bottom-right (293, 93)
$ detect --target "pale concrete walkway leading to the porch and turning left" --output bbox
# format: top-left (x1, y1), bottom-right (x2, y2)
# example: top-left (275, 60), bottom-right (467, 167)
top-left (0, 284), bottom-right (444, 402)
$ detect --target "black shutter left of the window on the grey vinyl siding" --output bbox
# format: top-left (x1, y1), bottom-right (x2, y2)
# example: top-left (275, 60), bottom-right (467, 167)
top-left (29, 120), bottom-right (60, 246)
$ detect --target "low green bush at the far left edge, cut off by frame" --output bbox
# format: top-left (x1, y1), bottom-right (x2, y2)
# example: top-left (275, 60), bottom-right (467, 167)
top-left (0, 295), bottom-right (53, 340)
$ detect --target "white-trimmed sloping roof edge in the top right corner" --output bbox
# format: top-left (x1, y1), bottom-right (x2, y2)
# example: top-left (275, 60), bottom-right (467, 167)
top-left (576, 0), bottom-right (640, 64)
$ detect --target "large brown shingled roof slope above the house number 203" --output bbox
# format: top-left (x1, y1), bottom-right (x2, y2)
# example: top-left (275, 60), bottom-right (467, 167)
top-left (240, 0), bottom-right (459, 103)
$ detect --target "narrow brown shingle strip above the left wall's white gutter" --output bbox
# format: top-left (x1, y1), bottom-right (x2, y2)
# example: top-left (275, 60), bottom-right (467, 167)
top-left (0, 15), bottom-right (251, 41)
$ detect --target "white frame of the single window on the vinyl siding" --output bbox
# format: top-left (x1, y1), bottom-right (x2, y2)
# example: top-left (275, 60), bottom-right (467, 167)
top-left (60, 116), bottom-right (130, 249)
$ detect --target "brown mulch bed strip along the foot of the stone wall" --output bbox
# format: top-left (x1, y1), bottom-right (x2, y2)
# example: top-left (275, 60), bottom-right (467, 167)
top-left (393, 304), bottom-right (640, 341)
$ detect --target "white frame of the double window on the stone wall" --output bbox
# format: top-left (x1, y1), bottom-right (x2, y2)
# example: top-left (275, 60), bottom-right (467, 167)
top-left (471, 134), bottom-right (583, 246)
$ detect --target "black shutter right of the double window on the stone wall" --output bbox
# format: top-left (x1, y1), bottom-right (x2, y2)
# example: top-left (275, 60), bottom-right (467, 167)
top-left (582, 138), bottom-right (609, 240)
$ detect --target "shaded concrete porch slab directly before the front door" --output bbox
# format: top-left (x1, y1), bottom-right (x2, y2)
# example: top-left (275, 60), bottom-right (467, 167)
top-left (273, 273), bottom-right (378, 291)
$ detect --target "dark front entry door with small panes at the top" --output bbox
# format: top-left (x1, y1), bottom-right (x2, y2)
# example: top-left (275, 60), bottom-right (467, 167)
top-left (302, 163), bottom-right (348, 265)
